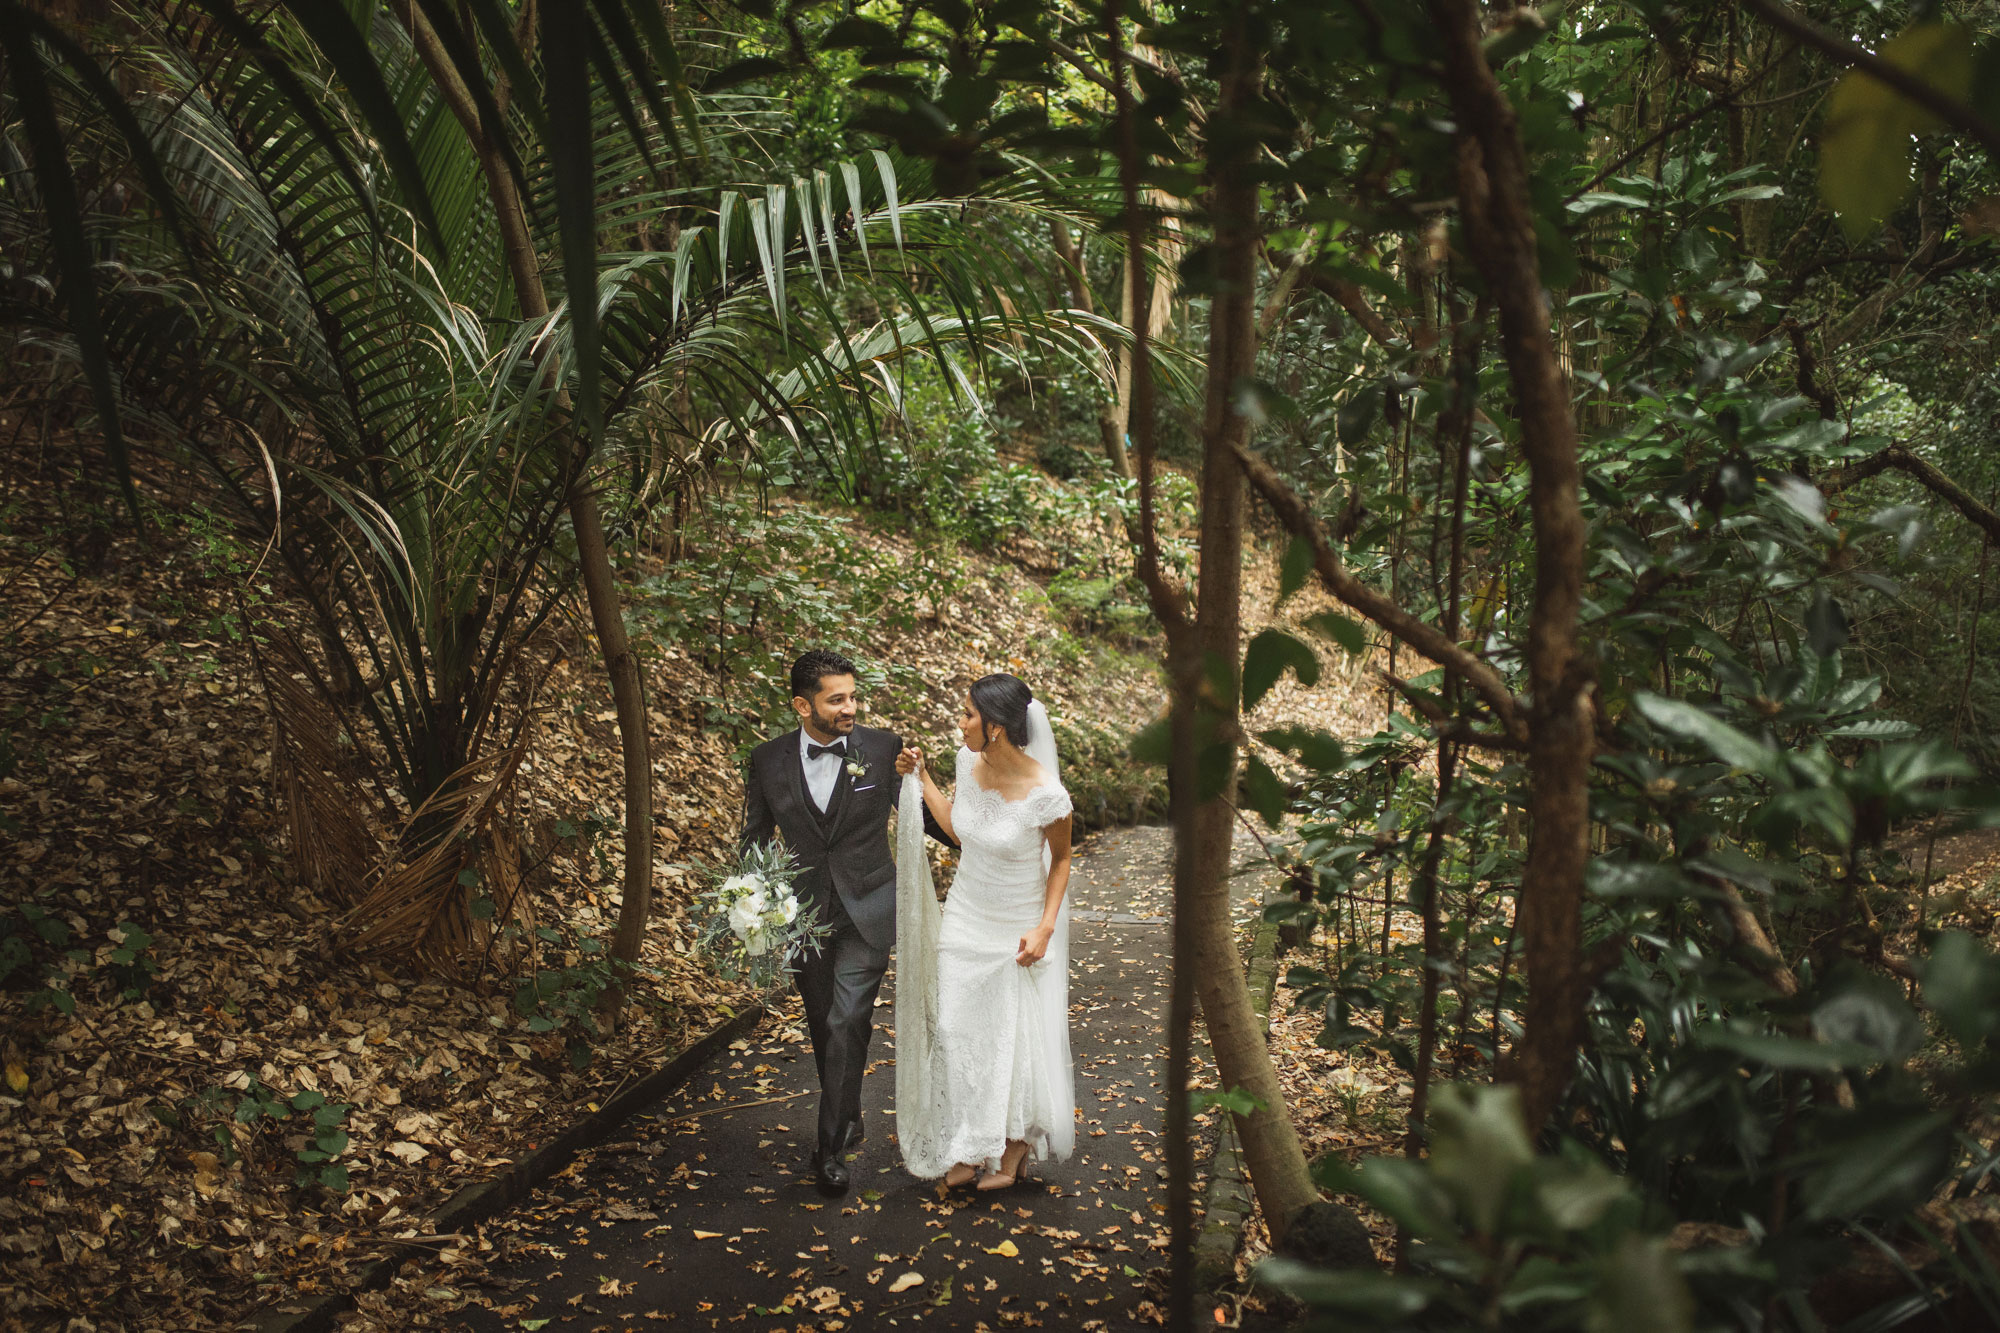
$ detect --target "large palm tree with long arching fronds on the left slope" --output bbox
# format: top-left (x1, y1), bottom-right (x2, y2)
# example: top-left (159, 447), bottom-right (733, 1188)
top-left (0, 0), bottom-right (1114, 976)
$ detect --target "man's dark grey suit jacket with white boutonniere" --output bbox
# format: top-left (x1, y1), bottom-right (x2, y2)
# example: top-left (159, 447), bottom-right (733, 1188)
top-left (742, 727), bottom-right (912, 951)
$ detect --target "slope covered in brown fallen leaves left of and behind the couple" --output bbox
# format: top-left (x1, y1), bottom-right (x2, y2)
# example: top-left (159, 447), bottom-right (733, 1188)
top-left (0, 438), bottom-right (1372, 1329)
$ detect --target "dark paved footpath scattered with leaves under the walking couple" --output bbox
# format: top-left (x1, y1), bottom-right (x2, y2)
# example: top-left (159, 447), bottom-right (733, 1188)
top-left (380, 829), bottom-right (1262, 1333)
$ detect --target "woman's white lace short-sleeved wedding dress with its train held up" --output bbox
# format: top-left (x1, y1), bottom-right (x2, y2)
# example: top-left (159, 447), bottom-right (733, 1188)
top-left (896, 736), bottom-right (1076, 1179)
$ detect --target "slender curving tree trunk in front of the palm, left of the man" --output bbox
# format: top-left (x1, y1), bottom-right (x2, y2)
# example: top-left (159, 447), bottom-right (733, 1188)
top-left (402, 0), bottom-right (652, 992)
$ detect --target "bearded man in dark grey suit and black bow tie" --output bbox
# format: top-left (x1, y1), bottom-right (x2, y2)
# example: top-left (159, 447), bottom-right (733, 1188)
top-left (742, 648), bottom-right (948, 1195)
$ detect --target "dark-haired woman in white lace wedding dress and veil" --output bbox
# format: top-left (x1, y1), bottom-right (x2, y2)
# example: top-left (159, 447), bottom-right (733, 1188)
top-left (896, 675), bottom-right (1076, 1189)
